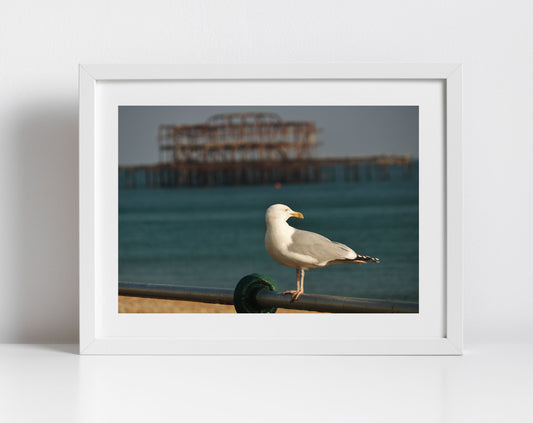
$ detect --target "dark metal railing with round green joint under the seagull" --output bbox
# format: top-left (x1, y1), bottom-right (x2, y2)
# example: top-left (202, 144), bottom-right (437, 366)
top-left (118, 274), bottom-right (418, 313)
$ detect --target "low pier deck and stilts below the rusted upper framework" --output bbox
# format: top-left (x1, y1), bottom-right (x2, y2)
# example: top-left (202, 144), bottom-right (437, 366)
top-left (119, 156), bottom-right (414, 188)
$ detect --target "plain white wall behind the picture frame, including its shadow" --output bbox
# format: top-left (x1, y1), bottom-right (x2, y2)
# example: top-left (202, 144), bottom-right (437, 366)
top-left (0, 0), bottom-right (533, 347)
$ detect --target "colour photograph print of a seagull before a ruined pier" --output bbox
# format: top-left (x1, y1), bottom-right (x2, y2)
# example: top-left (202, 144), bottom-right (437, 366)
top-left (118, 106), bottom-right (419, 313)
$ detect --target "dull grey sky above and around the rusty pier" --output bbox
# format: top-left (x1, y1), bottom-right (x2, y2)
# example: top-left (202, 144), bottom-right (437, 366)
top-left (119, 106), bottom-right (418, 165)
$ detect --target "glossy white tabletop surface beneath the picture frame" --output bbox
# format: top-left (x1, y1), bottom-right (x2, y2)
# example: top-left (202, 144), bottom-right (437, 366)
top-left (0, 343), bottom-right (533, 423)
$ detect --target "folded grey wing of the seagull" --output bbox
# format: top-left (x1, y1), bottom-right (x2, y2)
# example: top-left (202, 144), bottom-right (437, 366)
top-left (288, 229), bottom-right (356, 263)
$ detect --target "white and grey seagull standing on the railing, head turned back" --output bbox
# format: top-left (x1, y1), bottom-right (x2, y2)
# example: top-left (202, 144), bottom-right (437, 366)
top-left (265, 204), bottom-right (379, 303)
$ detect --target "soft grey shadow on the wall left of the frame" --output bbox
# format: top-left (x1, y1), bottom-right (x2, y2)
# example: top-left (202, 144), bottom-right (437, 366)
top-left (10, 102), bottom-right (79, 343)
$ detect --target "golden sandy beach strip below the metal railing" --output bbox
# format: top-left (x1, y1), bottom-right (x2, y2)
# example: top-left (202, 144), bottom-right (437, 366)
top-left (118, 295), bottom-right (313, 313)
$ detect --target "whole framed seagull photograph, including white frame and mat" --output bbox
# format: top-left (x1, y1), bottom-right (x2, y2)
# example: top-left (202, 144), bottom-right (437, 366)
top-left (79, 64), bottom-right (463, 355)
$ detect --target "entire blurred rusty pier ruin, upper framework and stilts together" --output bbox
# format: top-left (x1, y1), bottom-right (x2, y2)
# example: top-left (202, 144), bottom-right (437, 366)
top-left (119, 113), bottom-right (414, 188)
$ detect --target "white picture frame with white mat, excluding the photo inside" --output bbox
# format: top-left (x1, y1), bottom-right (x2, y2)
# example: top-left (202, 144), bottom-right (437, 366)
top-left (79, 64), bottom-right (463, 355)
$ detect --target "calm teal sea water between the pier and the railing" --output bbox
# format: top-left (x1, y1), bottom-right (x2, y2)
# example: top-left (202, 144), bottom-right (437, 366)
top-left (119, 171), bottom-right (418, 301)
